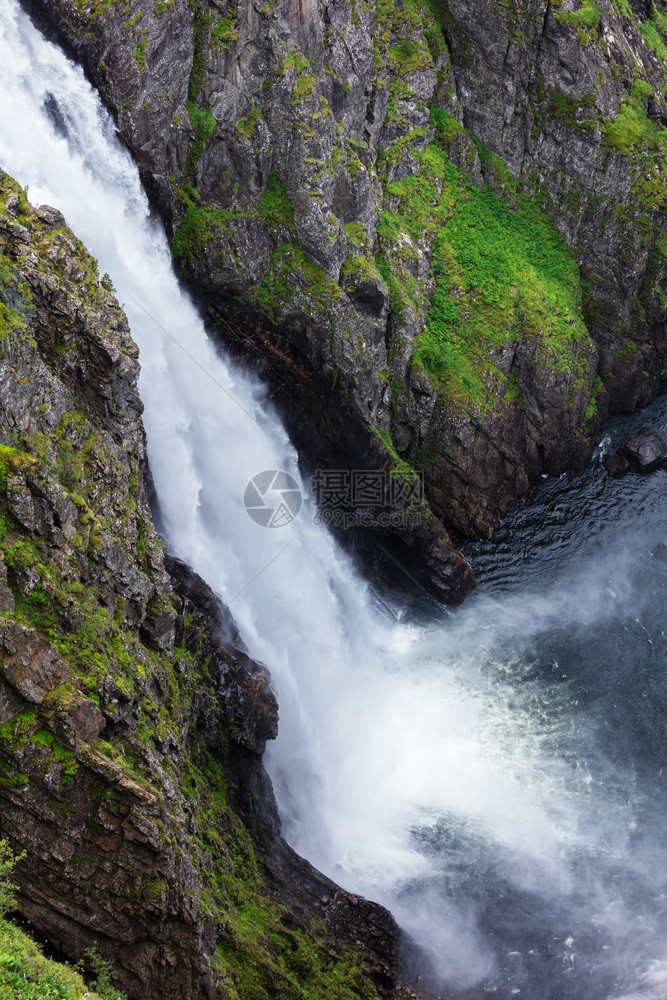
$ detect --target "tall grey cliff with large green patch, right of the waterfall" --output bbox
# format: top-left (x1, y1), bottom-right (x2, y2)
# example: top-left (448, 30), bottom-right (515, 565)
top-left (23, 0), bottom-right (667, 599)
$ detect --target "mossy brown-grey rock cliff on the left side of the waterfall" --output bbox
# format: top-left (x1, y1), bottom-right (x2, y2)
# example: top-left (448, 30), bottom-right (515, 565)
top-left (0, 172), bottom-right (398, 1000)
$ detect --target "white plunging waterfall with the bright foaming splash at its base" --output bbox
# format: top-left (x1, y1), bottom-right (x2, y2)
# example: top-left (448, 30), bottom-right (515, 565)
top-left (0, 0), bottom-right (664, 996)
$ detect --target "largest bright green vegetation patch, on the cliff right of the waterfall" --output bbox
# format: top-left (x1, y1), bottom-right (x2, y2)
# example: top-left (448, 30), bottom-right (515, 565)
top-left (380, 105), bottom-right (591, 409)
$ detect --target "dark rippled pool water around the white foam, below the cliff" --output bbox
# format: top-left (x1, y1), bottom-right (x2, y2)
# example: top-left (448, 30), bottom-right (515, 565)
top-left (406, 395), bottom-right (667, 1000)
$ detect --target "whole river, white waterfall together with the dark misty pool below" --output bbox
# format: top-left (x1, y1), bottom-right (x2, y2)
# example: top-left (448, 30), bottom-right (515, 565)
top-left (0, 0), bottom-right (667, 1000)
